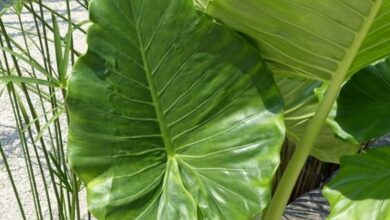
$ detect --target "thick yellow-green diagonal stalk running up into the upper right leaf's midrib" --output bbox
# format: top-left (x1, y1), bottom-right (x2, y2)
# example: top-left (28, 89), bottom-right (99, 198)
top-left (264, 0), bottom-right (383, 220)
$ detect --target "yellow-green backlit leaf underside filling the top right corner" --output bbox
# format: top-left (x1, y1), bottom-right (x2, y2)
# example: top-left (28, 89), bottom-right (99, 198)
top-left (194, 0), bottom-right (390, 81)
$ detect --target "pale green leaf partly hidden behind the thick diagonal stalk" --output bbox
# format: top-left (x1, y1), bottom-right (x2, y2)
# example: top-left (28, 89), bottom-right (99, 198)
top-left (275, 75), bottom-right (360, 163)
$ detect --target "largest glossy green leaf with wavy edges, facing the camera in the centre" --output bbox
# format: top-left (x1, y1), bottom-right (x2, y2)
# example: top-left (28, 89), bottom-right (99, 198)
top-left (67, 0), bottom-right (284, 219)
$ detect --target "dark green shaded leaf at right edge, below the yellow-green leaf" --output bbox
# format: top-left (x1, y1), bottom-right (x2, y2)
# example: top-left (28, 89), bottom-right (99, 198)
top-left (335, 60), bottom-right (390, 142)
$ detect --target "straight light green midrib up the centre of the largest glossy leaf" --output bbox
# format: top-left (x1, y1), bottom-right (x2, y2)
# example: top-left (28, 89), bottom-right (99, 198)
top-left (136, 20), bottom-right (175, 158)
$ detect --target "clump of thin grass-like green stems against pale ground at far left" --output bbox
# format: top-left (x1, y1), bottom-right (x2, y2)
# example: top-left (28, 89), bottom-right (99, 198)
top-left (0, 0), bottom-right (88, 219)
